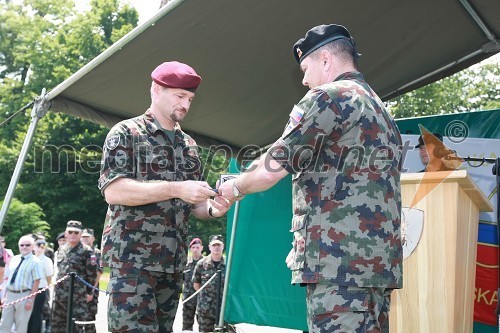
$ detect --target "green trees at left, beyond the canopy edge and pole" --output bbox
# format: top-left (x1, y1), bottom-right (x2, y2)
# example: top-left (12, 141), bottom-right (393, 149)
top-left (0, 0), bottom-right (138, 241)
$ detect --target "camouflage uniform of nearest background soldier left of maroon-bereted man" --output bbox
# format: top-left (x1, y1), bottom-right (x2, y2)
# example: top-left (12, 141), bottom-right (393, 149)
top-left (51, 243), bottom-right (97, 333)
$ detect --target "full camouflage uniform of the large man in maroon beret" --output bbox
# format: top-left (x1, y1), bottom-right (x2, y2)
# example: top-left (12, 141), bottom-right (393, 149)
top-left (99, 110), bottom-right (203, 332)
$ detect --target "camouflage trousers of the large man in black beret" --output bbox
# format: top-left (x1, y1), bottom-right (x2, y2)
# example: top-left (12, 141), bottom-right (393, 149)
top-left (306, 284), bottom-right (392, 333)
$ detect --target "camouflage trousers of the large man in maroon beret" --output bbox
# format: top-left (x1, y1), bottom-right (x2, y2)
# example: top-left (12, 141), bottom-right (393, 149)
top-left (108, 268), bottom-right (182, 333)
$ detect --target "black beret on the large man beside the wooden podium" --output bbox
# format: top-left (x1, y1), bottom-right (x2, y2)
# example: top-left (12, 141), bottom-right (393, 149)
top-left (292, 24), bottom-right (358, 64)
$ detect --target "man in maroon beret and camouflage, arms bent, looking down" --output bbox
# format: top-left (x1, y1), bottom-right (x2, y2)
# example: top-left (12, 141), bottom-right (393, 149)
top-left (99, 61), bottom-right (230, 333)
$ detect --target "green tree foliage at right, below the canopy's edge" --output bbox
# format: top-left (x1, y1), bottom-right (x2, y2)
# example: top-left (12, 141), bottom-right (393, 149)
top-left (389, 64), bottom-right (500, 118)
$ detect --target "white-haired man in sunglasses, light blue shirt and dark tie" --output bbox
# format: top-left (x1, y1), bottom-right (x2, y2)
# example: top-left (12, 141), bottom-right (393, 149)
top-left (0, 235), bottom-right (44, 333)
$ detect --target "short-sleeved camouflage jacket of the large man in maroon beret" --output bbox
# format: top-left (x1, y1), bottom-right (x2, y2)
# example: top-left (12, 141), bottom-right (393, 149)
top-left (99, 110), bottom-right (203, 273)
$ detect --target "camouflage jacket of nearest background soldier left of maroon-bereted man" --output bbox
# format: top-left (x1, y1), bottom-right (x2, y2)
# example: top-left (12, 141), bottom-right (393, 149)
top-left (56, 243), bottom-right (98, 298)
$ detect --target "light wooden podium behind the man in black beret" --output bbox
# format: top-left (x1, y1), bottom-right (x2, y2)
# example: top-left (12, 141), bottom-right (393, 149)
top-left (389, 170), bottom-right (493, 333)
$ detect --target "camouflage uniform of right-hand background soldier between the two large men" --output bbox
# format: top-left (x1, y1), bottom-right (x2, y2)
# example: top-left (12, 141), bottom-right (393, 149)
top-left (193, 255), bottom-right (226, 332)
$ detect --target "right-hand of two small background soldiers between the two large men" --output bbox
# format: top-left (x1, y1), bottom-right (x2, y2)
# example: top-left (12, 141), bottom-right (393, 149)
top-left (193, 235), bottom-right (226, 332)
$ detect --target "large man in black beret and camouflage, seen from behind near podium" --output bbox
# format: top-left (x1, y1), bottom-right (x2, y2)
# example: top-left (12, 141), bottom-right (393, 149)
top-left (219, 24), bottom-right (403, 333)
